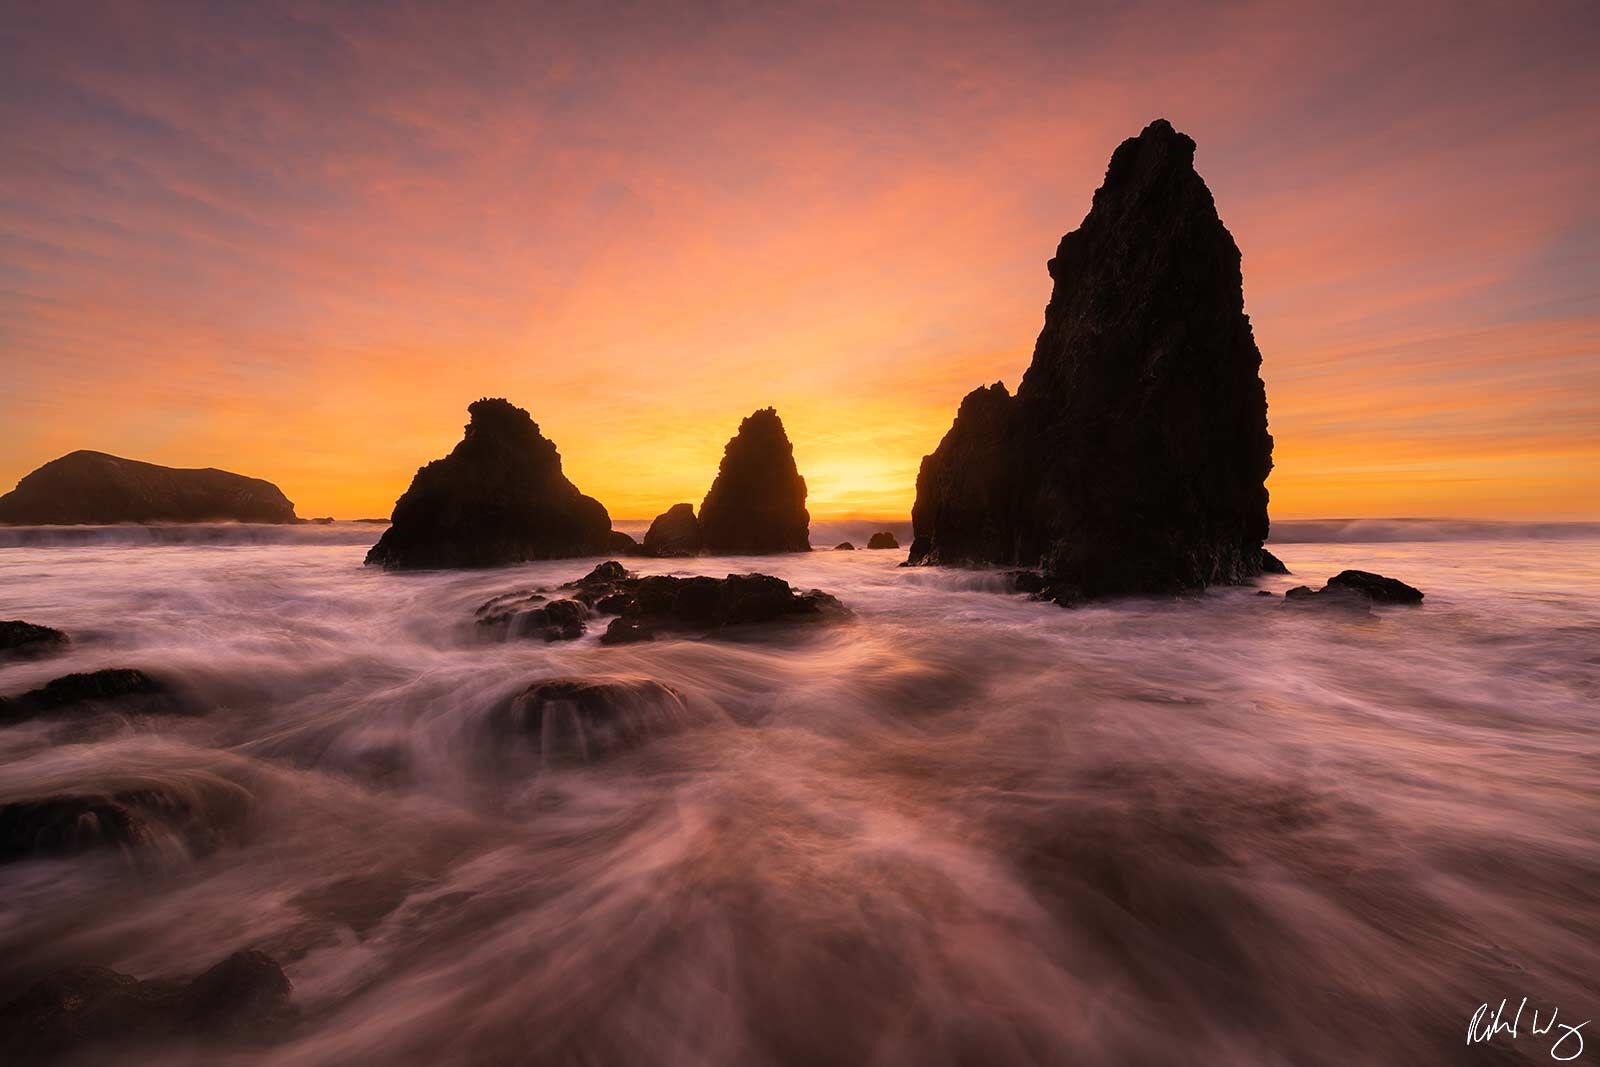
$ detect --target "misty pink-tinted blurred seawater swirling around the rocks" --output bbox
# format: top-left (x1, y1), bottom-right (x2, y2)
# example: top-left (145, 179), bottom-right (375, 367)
top-left (0, 523), bottom-right (1600, 1067)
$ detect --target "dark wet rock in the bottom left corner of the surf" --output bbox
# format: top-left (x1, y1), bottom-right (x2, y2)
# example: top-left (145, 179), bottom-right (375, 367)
top-left (0, 952), bottom-right (298, 1064)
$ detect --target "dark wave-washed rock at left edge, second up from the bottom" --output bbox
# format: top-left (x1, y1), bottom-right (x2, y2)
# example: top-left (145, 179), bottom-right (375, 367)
top-left (0, 782), bottom-right (250, 862)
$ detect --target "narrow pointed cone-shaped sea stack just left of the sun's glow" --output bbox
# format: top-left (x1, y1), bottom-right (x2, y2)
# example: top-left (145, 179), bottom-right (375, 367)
top-left (699, 408), bottom-right (811, 555)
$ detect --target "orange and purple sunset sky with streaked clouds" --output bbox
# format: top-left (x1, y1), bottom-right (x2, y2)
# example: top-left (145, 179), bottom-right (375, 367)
top-left (0, 0), bottom-right (1600, 518)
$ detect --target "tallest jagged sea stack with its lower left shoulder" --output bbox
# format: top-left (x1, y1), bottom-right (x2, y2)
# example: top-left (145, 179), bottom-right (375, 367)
top-left (909, 120), bottom-right (1272, 600)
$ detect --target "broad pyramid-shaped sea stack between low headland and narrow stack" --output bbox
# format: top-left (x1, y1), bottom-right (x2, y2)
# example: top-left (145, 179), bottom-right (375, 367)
top-left (366, 400), bottom-right (611, 568)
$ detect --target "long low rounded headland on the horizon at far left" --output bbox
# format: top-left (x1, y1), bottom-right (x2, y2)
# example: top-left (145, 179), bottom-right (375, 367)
top-left (0, 451), bottom-right (296, 526)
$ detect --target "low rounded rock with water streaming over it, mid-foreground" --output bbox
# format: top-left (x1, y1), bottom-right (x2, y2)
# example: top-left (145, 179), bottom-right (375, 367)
top-left (494, 678), bottom-right (690, 763)
